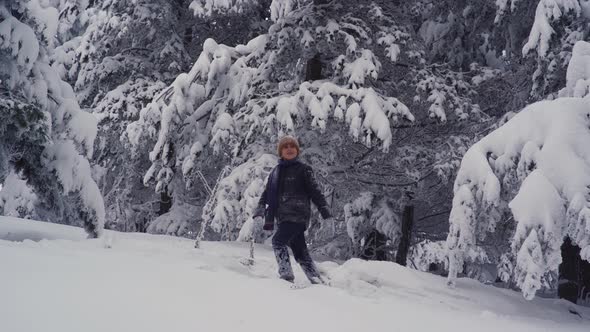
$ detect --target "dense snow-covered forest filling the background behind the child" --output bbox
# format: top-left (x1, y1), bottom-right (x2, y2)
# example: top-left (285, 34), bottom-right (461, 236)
top-left (0, 0), bottom-right (590, 303)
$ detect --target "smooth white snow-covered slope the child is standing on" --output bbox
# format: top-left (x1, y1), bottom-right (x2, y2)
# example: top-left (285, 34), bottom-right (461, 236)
top-left (0, 217), bottom-right (590, 332)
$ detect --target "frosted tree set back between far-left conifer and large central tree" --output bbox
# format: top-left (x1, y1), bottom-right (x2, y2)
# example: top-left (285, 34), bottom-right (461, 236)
top-left (52, 0), bottom-right (206, 233)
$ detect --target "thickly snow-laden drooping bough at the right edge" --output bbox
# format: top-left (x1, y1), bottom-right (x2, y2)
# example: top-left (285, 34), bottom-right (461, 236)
top-left (447, 98), bottom-right (590, 299)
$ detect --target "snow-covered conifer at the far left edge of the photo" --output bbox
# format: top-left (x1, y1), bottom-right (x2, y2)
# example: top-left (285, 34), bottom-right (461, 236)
top-left (0, 0), bottom-right (105, 237)
